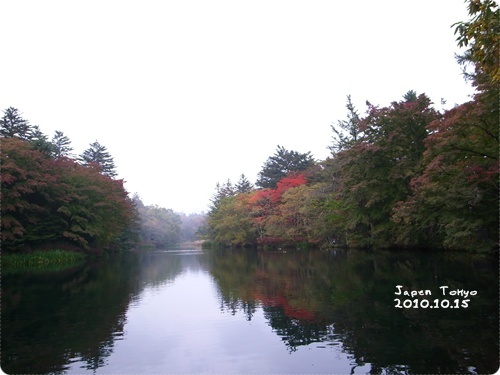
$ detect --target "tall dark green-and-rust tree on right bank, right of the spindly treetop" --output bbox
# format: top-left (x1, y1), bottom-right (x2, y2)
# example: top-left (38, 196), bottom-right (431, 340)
top-left (331, 94), bottom-right (440, 248)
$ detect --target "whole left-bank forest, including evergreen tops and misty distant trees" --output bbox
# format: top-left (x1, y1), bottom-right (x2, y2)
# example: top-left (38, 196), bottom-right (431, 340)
top-left (0, 114), bottom-right (204, 253)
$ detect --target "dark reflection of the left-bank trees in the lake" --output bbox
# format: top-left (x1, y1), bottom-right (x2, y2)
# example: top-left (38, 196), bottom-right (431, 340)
top-left (1, 257), bottom-right (138, 374)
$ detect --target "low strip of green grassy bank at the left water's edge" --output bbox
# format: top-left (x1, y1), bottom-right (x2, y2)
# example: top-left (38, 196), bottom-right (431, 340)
top-left (2, 250), bottom-right (86, 272)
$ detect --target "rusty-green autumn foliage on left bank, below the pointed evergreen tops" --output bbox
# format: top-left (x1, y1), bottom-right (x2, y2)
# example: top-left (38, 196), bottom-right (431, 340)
top-left (0, 137), bottom-right (135, 251)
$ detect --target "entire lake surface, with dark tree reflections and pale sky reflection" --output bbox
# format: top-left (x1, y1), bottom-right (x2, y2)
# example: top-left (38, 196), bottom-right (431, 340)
top-left (1, 250), bottom-right (499, 374)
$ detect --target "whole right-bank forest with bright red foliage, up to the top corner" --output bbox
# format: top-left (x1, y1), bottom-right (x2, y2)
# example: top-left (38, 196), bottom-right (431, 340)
top-left (205, 1), bottom-right (500, 251)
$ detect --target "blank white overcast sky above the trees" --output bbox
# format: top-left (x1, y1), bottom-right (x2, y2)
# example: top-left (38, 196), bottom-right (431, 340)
top-left (0, 0), bottom-right (473, 213)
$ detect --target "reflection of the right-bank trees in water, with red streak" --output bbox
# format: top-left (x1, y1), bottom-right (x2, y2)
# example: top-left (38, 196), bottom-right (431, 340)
top-left (206, 251), bottom-right (499, 373)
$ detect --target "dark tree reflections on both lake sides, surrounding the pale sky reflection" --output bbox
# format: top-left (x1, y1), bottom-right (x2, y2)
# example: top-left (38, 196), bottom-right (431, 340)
top-left (1, 250), bottom-right (499, 373)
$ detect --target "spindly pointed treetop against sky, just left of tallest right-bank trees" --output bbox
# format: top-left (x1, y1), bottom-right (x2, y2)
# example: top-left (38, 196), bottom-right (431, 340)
top-left (328, 95), bottom-right (361, 155)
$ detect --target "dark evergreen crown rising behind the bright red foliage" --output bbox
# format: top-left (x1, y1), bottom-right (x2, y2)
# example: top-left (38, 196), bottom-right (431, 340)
top-left (256, 145), bottom-right (315, 189)
